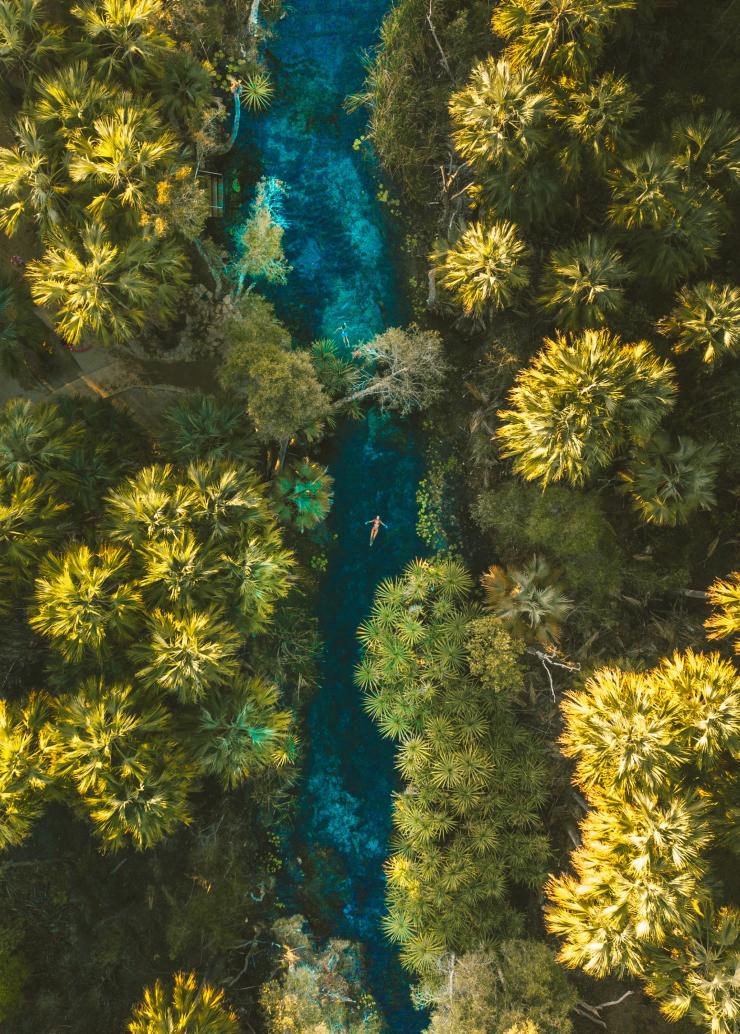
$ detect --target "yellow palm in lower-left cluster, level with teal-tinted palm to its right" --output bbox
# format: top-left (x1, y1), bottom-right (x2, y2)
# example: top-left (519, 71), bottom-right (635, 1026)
top-left (51, 678), bottom-right (169, 797)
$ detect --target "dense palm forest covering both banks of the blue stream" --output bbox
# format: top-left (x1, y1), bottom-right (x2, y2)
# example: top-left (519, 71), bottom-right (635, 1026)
top-left (0, 0), bottom-right (740, 1034)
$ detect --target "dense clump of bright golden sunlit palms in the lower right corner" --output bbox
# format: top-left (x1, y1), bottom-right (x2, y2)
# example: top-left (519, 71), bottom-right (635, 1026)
top-left (547, 650), bottom-right (740, 1034)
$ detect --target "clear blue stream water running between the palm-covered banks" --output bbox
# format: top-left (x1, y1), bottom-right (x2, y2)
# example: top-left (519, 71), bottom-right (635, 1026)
top-left (230, 0), bottom-right (425, 1034)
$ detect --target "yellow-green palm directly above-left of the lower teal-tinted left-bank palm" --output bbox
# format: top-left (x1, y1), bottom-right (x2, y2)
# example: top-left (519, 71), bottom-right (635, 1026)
top-left (132, 610), bottom-right (242, 704)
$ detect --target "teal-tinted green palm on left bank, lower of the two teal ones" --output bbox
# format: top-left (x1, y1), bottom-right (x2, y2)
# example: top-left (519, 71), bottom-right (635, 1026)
top-left (193, 676), bottom-right (292, 789)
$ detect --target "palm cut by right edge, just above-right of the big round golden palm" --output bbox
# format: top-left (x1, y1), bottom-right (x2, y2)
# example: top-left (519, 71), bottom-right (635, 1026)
top-left (658, 281), bottom-right (740, 366)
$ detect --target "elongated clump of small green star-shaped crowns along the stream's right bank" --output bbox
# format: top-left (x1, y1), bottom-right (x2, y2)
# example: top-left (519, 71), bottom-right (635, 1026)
top-left (356, 560), bottom-right (546, 976)
